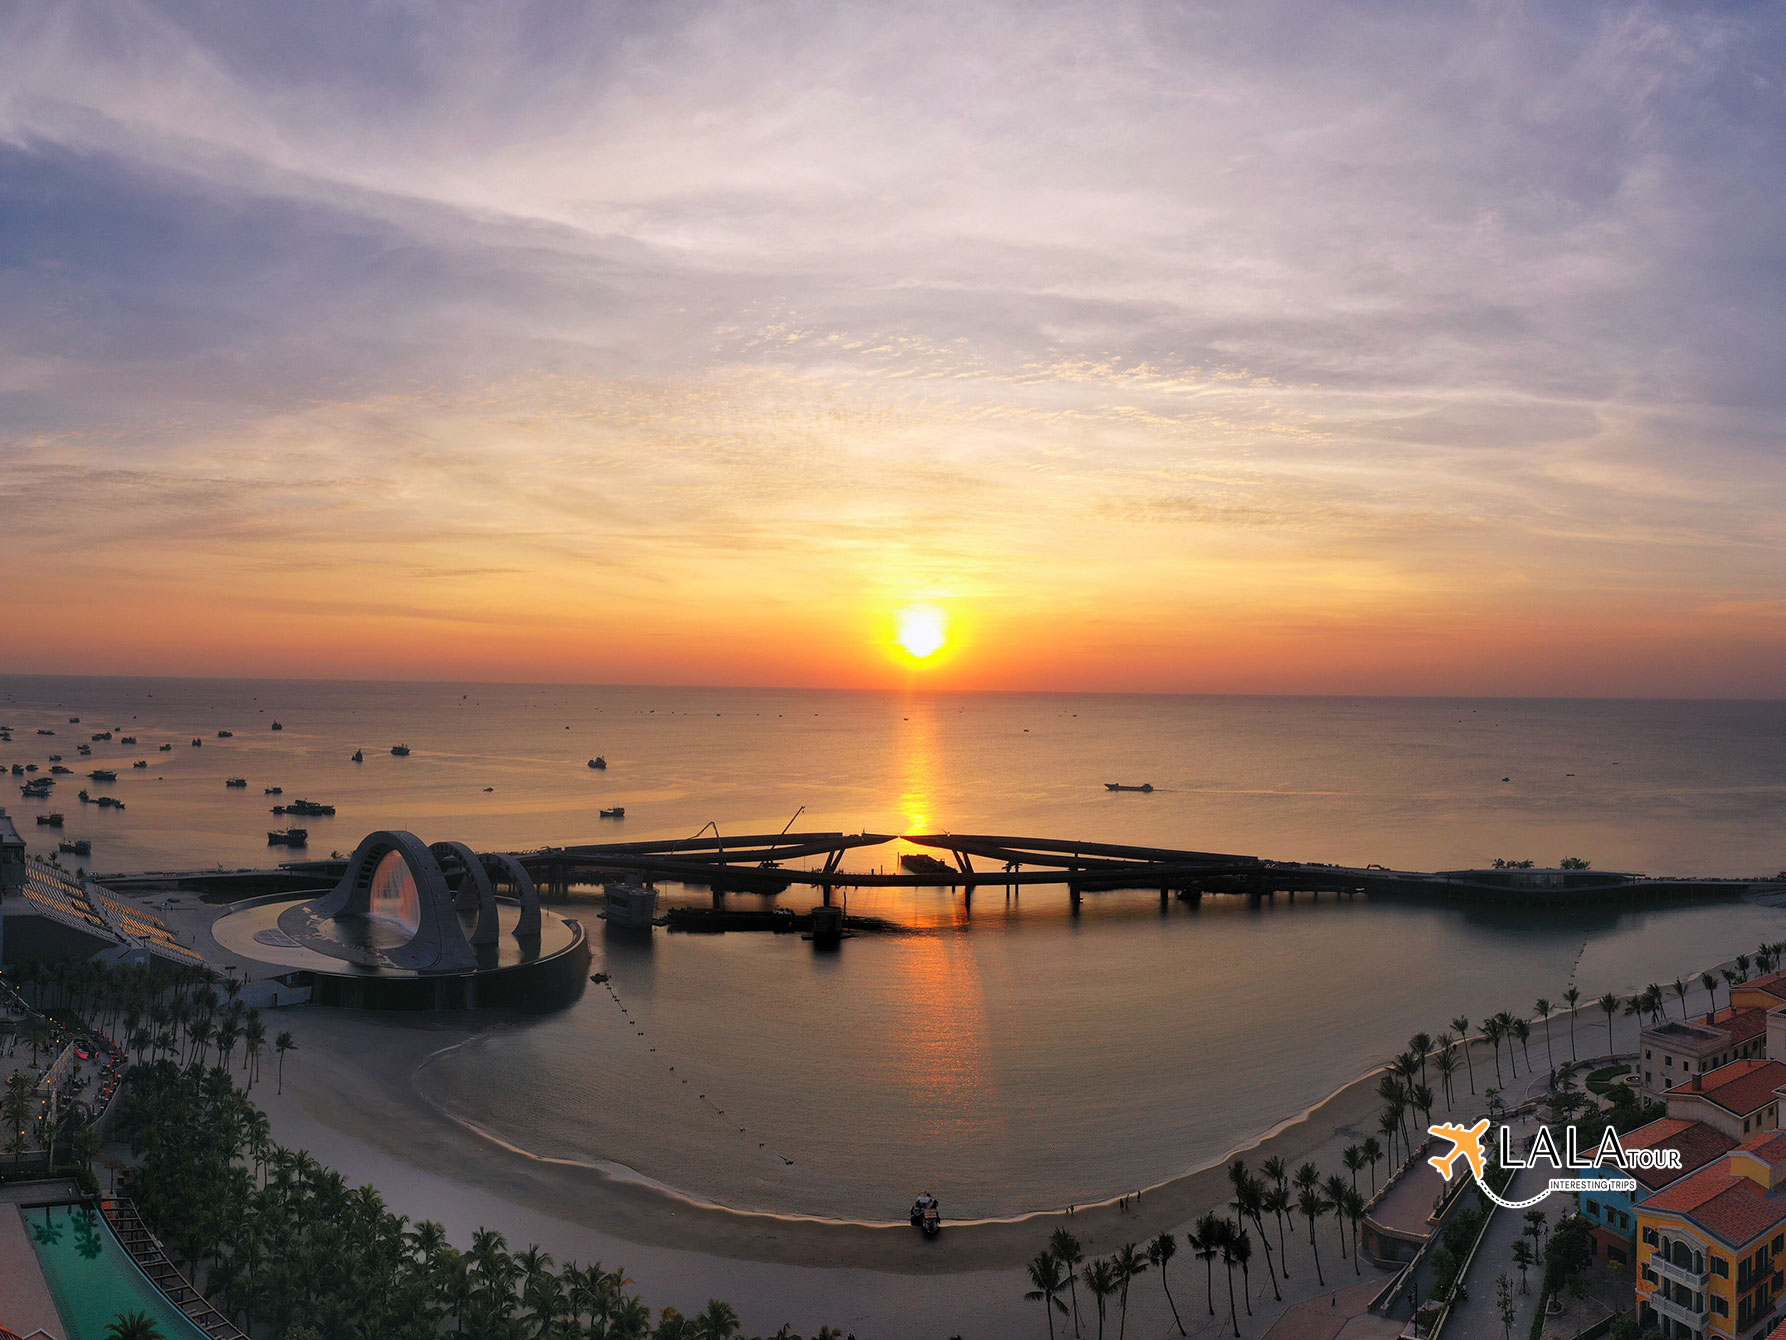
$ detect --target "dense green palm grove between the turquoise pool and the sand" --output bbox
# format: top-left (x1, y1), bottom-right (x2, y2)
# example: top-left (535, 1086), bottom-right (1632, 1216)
top-left (118, 1059), bottom-right (841, 1340)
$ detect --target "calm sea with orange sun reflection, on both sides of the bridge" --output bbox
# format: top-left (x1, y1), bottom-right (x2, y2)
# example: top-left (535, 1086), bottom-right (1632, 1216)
top-left (0, 677), bottom-right (1786, 1219)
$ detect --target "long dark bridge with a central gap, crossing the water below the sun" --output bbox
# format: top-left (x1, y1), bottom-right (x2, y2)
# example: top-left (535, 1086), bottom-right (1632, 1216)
top-left (516, 833), bottom-right (1748, 906)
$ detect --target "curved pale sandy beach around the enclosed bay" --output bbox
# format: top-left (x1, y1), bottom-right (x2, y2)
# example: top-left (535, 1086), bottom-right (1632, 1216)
top-left (241, 1008), bottom-right (1657, 1336)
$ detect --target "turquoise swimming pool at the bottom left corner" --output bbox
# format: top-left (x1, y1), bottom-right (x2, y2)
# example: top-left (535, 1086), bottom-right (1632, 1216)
top-left (23, 1204), bottom-right (207, 1340)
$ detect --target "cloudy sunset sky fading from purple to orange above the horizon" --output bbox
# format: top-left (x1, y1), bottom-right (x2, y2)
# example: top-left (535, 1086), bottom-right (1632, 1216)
top-left (0, 0), bottom-right (1786, 697)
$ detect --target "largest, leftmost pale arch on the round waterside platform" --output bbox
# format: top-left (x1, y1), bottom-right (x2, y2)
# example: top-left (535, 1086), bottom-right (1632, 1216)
top-left (311, 829), bottom-right (478, 972)
